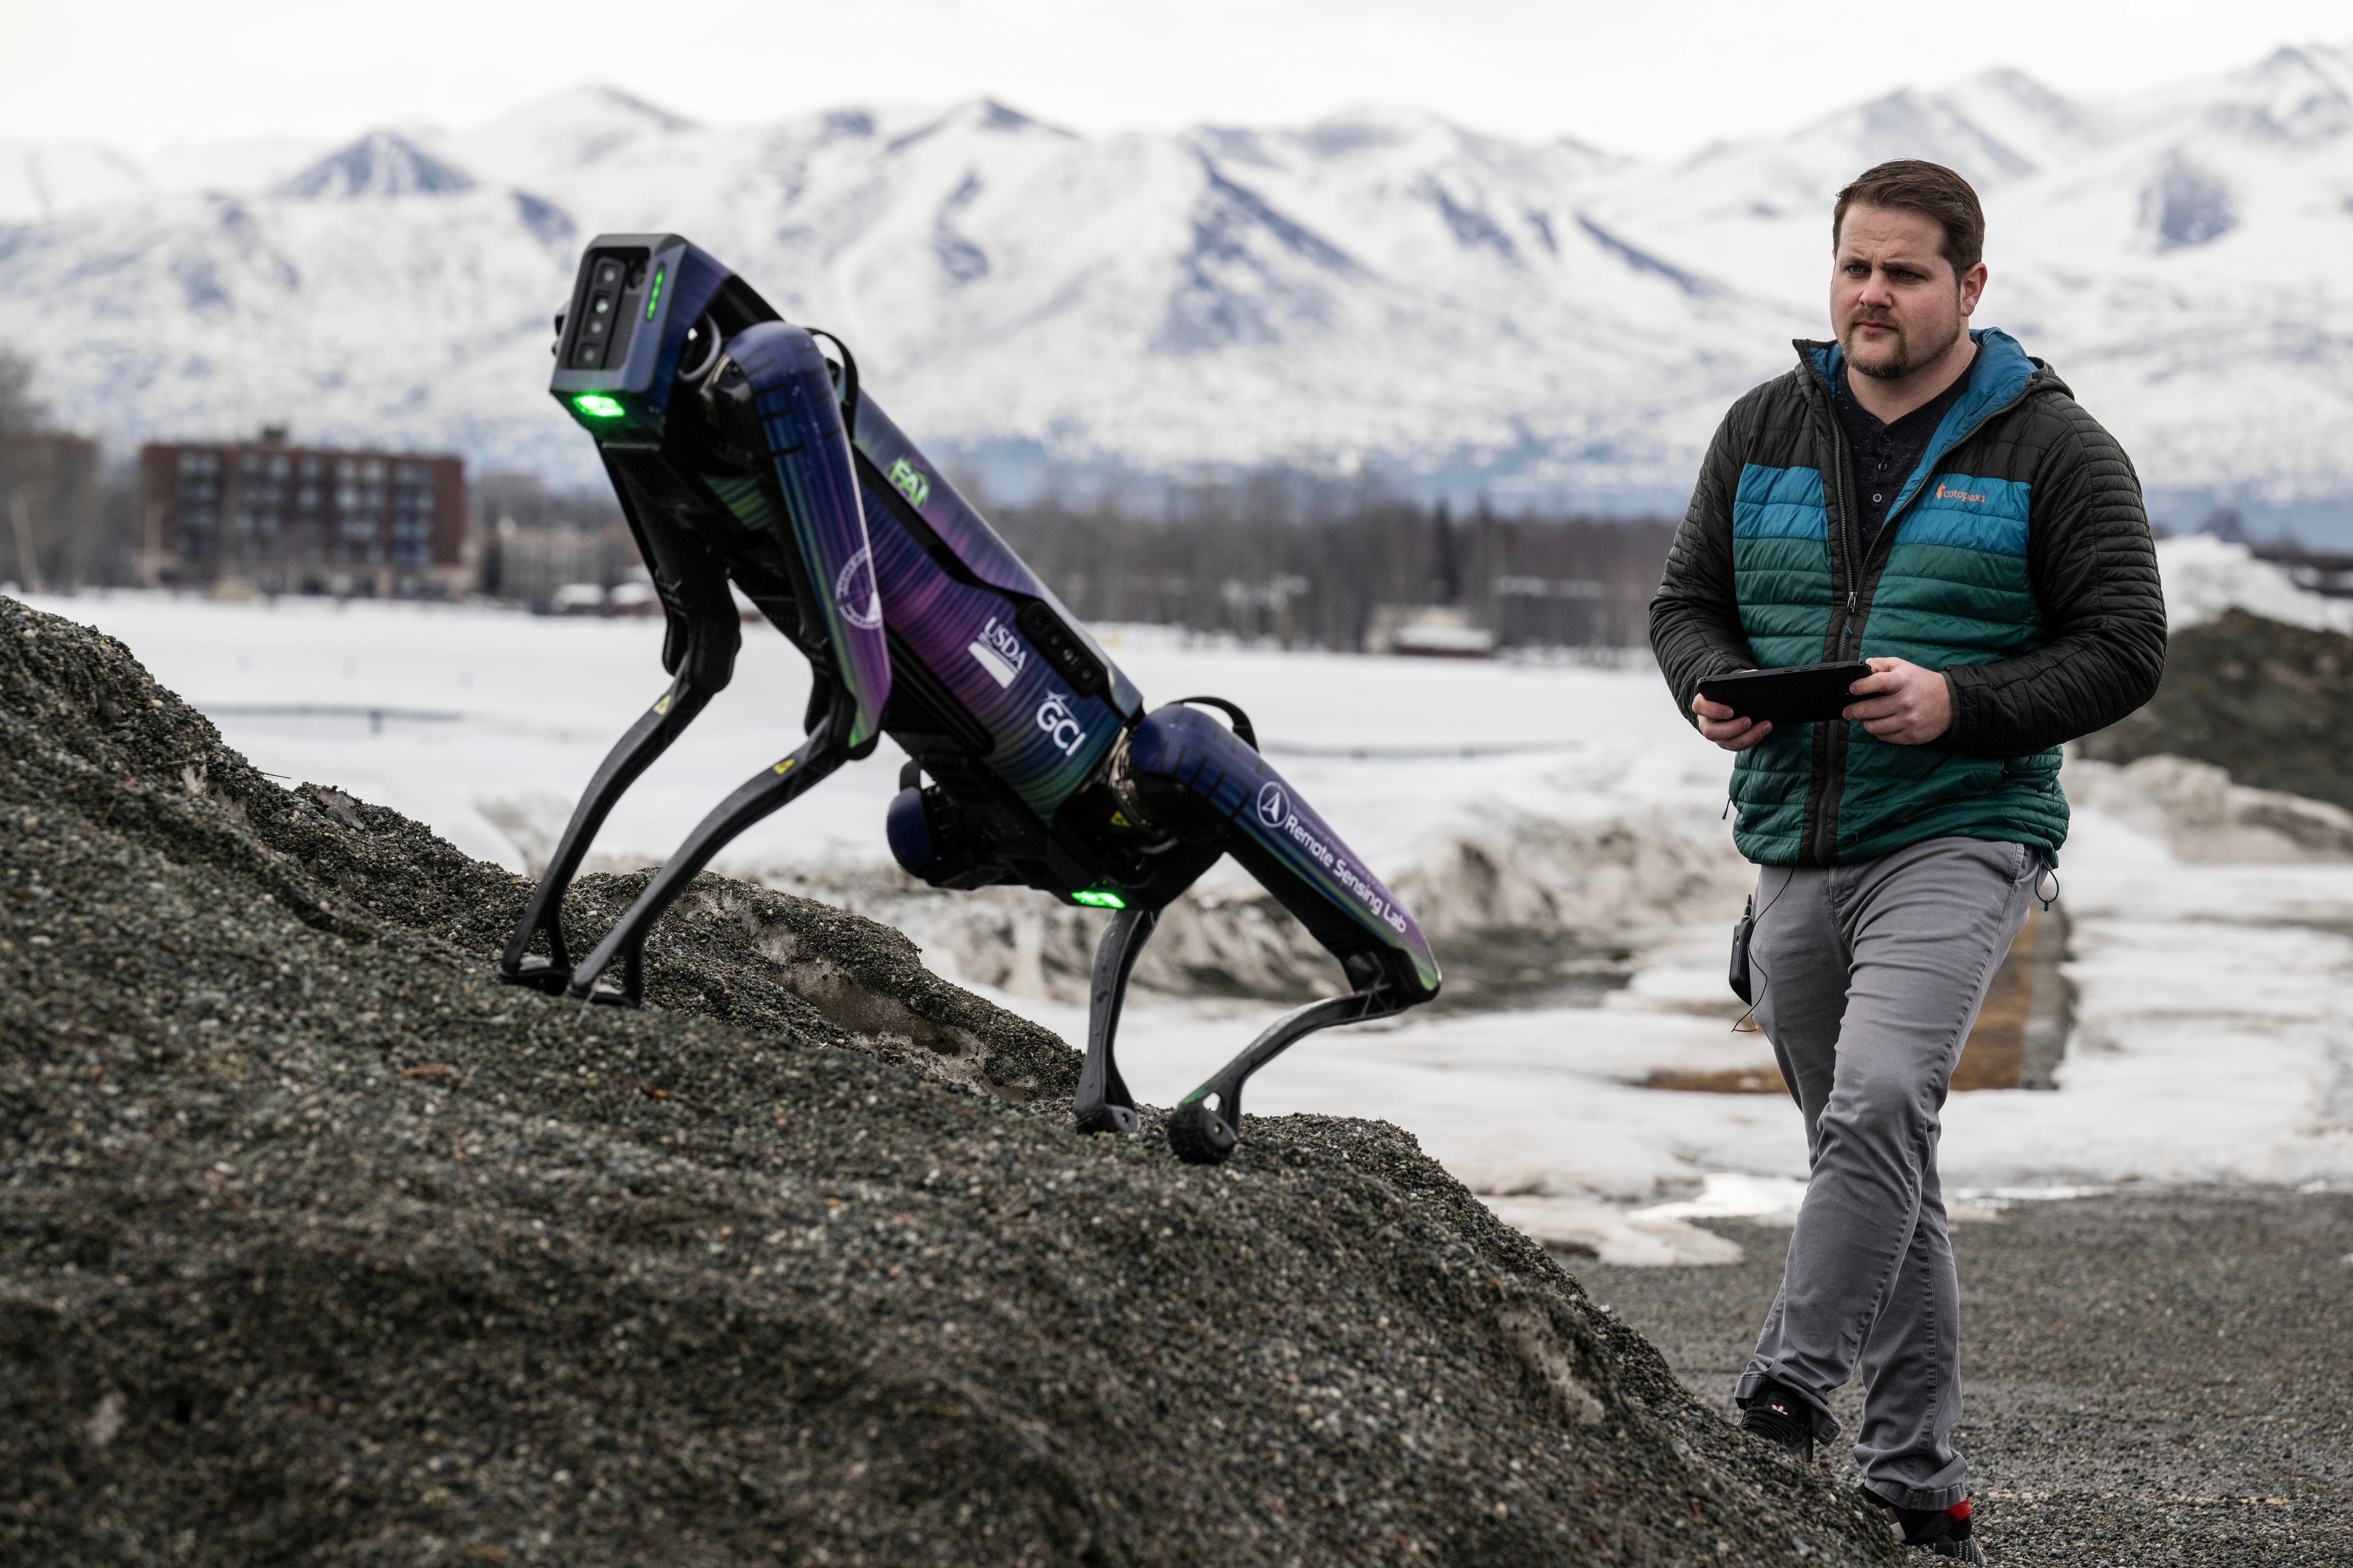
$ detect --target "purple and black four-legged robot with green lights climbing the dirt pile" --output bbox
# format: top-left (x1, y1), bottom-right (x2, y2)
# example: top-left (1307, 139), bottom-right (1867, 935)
top-left (499, 233), bottom-right (1438, 1163)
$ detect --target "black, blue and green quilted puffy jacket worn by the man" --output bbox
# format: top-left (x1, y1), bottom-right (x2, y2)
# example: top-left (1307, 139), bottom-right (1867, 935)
top-left (1649, 332), bottom-right (2165, 866)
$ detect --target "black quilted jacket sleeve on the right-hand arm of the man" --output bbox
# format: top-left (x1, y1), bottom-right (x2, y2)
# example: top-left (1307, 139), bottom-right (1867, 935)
top-left (1939, 396), bottom-right (2165, 756)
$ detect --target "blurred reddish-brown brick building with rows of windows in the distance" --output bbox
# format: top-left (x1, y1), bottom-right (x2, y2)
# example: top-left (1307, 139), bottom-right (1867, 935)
top-left (139, 426), bottom-right (466, 598)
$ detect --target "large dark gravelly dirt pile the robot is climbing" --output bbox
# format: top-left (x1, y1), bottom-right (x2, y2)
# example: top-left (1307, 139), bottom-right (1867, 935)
top-left (0, 600), bottom-right (1899, 1566)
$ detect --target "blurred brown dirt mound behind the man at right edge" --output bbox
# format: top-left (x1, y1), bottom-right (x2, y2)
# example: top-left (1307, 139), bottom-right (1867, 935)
top-left (2082, 608), bottom-right (2353, 810)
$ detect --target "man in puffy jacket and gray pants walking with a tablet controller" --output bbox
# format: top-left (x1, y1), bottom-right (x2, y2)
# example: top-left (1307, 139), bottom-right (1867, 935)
top-left (1649, 160), bottom-right (2165, 1563)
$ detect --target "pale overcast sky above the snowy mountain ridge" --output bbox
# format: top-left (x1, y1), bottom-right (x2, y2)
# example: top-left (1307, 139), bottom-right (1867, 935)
top-left (0, 0), bottom-right (2353, 155)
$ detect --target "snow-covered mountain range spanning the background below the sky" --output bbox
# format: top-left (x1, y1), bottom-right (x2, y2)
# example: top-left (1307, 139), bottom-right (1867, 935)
top-left (0, 47), bottom-right (2353, 521)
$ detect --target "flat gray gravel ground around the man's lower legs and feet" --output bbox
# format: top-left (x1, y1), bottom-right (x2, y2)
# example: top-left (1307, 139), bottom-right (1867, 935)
top-left (1572, 1189), bottom-right (2353, 1568)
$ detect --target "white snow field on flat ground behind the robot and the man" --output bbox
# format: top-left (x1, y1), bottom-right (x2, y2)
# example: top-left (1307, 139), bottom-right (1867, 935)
top-left (35, 542), bottom-right (2353, 1262)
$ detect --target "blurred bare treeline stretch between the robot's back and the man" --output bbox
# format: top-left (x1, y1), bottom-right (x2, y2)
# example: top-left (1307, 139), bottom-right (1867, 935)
top-left (986, 471), bottom-right (1675, 650)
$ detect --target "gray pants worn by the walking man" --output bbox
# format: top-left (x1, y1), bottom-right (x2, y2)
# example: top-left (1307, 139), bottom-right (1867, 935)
top-left (1732, 838), bottom-right (2040, 1509)
